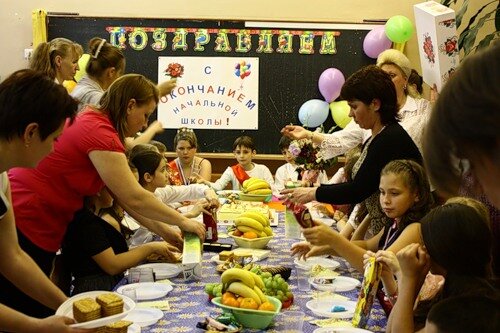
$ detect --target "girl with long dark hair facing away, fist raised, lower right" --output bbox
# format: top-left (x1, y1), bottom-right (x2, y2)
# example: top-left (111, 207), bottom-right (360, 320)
top-left (387, 199), bottom-right (498, 333)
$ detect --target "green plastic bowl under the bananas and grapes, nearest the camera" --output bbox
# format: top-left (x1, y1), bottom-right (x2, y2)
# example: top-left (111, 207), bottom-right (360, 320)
top-left (212, 296), bottom-right (281, 329)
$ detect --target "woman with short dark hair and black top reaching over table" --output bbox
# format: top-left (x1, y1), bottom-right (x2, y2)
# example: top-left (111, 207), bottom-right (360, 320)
top-left (282, 65), bottom-right (422, 235)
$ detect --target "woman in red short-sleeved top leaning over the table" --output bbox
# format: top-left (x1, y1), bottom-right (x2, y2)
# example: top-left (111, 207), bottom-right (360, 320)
top-left (5, 74), bottom-right (205, 311)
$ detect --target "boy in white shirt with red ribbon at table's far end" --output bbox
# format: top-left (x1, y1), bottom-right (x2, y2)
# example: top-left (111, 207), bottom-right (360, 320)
top-left (198, 135), bottom-right (274, 191)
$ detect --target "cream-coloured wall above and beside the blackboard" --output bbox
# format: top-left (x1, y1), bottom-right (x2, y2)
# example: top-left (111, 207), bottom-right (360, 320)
top-left (0, 0), bottom-right (424, 78)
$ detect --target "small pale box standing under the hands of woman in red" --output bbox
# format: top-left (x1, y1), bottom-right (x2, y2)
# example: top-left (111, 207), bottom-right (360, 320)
top-left (182, 232), bottom-right (203, 280)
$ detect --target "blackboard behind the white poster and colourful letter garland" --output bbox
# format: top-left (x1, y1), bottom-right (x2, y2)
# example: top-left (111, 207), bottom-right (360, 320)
top-left (48, 16), bottom-right (374, 154)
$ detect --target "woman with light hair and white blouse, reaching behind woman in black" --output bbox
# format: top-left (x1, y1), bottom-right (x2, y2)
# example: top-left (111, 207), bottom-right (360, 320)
top-left (282, 49), bottom-right (431, 159)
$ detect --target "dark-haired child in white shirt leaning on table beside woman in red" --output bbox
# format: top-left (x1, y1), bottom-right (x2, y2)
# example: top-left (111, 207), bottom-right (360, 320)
top-left (129, 145), bottom-right (219, 245)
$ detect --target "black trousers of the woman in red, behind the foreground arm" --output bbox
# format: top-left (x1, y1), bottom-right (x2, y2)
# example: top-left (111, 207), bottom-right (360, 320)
top-left (0, 230), bottom-right (55, 318)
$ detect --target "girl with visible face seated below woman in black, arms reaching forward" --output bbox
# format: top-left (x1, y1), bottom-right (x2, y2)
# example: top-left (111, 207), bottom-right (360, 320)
top-left (292, 160), bottom-right (433, 271)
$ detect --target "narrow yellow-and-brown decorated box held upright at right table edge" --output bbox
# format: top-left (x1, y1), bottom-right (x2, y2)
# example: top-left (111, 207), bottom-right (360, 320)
top-left (352, 257), bottom-right (382, 327)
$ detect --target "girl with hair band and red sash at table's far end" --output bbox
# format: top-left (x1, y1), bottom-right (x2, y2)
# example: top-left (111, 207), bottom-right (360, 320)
top-left (169, 127), bottom-right (212, 185)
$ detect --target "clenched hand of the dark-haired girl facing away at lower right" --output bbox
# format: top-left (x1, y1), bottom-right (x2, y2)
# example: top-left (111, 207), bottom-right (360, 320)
top-left (396, 243), bottom-right (431, 281)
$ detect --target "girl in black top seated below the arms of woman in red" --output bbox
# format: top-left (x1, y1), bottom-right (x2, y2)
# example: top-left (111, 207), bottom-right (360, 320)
top-left (62, 187), bottom-right (176, 295)
